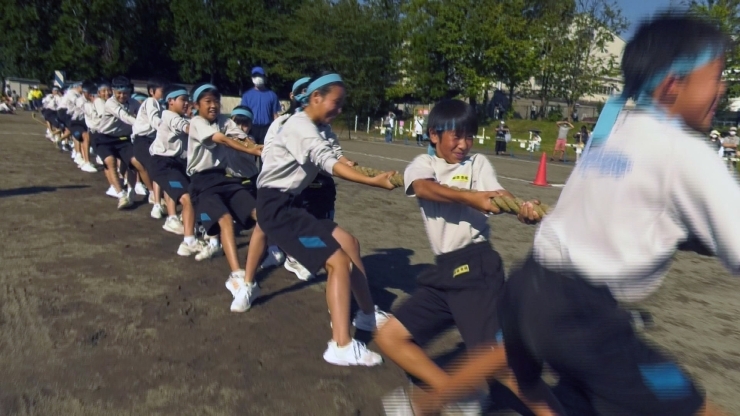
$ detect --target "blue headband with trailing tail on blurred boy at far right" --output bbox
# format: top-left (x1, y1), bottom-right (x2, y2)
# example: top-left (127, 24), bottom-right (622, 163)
top-left (584, 47), bottom-right (725, 150)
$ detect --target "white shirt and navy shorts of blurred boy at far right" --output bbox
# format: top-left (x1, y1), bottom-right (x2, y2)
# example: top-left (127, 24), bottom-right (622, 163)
top-left (500, 110), bottom-right (740, 416)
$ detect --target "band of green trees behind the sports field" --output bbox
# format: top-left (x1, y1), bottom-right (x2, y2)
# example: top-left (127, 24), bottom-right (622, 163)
top-left (0, 0), bottom-right (740, 114)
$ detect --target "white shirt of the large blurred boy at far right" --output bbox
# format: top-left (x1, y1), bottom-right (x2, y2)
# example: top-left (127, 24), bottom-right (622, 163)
top-left (534, 111), bottom-right (740, 301)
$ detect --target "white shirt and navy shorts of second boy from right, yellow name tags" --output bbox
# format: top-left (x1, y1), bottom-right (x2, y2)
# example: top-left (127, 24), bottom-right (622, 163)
top-left (395, 154), bottom-right (504, 354)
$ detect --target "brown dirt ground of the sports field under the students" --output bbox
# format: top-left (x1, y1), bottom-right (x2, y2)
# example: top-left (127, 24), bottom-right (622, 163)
top-left (0, 114), bottom-right (740, 416)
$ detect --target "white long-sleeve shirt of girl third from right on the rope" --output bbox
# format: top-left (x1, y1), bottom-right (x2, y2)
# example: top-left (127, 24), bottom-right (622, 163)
top-left (257, 112), bottom-right (338, 195)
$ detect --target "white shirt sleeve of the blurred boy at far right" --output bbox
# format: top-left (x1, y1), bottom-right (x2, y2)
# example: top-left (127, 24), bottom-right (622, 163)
top-left (669, 140), bottom-right (740, 275)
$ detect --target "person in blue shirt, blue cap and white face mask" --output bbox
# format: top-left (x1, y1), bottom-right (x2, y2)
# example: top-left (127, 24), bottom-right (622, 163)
top-left (241, 66), bottom-right (281, 148)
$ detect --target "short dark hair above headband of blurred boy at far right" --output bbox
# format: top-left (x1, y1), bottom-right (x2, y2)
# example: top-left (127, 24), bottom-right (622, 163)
top-left (622, 11), bottom-right (732, 98)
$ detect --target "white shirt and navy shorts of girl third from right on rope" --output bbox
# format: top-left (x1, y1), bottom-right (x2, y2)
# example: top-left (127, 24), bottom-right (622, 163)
top-left (257, 112), bottom-right (340, 274)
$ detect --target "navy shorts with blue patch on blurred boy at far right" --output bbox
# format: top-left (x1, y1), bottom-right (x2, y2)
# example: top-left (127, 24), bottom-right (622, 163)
top-left (499, 257), bottom-right (704, 416)
